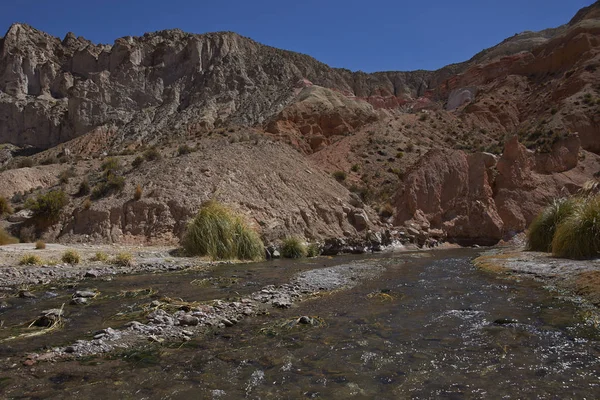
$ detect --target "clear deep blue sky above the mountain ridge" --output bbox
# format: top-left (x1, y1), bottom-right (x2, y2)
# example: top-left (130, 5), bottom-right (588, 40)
top-left (0, 0), bottom-right (593, 72)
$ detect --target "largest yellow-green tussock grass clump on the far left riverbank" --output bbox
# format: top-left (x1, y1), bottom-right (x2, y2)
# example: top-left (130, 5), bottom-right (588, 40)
top-left (183, 200), bottom-right (264, 260)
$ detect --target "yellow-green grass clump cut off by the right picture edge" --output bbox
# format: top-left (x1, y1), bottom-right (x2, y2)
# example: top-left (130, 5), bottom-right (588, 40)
top-left (552, 195), bottom-right (600, 259)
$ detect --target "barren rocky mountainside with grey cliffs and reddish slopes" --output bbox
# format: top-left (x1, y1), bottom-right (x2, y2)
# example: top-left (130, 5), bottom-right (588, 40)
top-left (0, 3), bottom-right (600, 247)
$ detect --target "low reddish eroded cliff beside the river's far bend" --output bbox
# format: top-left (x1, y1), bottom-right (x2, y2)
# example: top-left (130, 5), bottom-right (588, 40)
top-left (395, 135), bottom-right (600, 243)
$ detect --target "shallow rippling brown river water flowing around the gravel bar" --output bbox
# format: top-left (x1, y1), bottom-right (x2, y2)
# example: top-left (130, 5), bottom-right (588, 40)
top-left (0, 250), bottom-right (600, 399)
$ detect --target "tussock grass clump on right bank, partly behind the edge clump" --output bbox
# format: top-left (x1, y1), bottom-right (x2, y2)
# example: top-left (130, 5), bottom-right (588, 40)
top-left (527, 198), bottom-right (576, 252)
